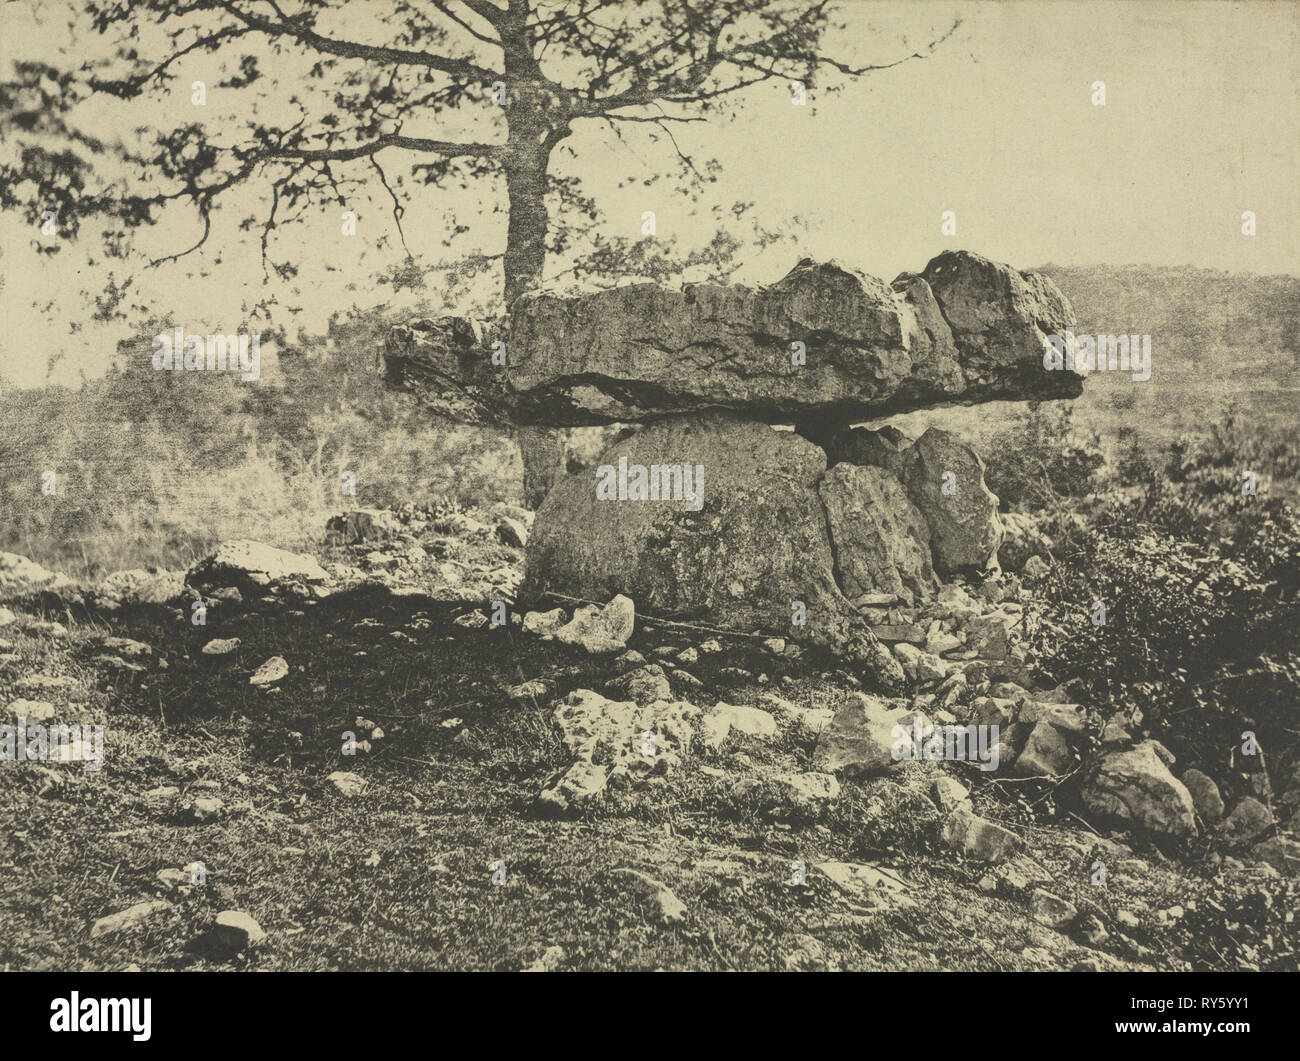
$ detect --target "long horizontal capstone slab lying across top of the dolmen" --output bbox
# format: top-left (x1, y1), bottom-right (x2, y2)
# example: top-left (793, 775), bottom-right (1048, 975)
top-left (385, 252), bottom-right (1082, 428)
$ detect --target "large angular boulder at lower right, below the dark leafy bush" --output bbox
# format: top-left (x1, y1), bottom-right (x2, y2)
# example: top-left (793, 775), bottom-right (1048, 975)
top-left (1080, 740), bottom-right (1196, 836)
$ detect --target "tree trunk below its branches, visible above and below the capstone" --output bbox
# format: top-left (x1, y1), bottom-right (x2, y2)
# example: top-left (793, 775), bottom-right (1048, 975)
top-left (504, 146), bottom-right (568, 508)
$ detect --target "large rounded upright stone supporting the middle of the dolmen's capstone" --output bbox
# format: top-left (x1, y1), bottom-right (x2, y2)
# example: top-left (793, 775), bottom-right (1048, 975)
top-left (520, 413), bottom-right (871, 663)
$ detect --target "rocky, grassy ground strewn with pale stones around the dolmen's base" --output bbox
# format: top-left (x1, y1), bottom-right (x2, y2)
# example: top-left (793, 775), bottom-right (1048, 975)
top-left (0, 506), bottom-right (1297, 970)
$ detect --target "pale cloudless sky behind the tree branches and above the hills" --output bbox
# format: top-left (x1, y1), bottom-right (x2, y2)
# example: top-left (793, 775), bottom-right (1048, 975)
top-left (0, 0), bottom-right (1300, 386)
